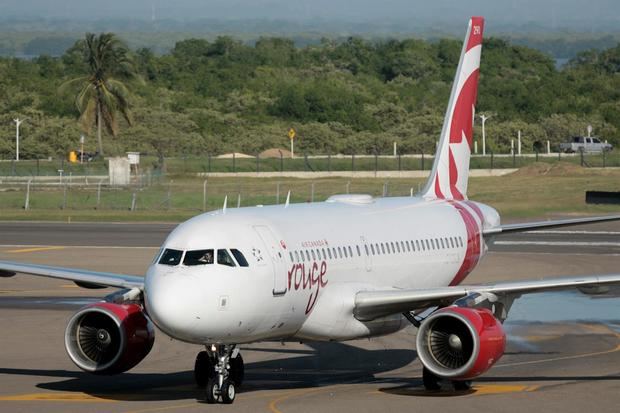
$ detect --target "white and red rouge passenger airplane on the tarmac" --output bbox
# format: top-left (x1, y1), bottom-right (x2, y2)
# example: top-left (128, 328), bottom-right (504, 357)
top-left (0, 17), bottom-right (620, 404)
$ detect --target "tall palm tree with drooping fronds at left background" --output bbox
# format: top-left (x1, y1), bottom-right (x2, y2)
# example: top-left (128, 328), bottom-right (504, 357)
top-left (61, 33), bottom-right (135, 155)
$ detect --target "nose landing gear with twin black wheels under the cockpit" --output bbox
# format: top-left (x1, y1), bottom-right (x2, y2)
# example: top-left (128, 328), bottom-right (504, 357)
top-left (194, 344), bottom-right (244, 404)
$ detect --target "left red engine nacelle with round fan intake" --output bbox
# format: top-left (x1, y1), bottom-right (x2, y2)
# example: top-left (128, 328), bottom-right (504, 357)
top-left (65, 303), bottom-right (155, 374)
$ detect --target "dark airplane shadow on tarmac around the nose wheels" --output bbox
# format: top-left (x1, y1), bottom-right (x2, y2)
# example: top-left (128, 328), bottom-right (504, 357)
top-left (0, 342), bottom-right (417, 401)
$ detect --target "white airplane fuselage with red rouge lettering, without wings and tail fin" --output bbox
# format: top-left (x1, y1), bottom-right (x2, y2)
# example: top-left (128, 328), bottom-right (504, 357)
top-left (144, 195), bottom-right (499, 344)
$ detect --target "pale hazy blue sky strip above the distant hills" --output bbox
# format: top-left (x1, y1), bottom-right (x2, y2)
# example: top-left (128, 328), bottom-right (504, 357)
top-left (0, 0), bottom-right (620, 28)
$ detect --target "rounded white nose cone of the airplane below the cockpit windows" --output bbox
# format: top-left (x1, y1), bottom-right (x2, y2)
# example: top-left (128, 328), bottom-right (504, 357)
top-left (144, 266), bottom-right (197, 340)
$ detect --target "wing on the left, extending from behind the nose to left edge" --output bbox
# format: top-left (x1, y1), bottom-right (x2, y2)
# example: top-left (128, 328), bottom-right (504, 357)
top-left (0, 261), bottom-right (144, 289)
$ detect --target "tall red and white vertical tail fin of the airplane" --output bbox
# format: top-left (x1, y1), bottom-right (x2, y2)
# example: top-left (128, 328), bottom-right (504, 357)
top-left (422, 17), bottom-right (484, 200)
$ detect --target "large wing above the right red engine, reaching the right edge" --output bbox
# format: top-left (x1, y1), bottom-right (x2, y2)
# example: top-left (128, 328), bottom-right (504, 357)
top-left (354, 274), bottom-right (620, 321)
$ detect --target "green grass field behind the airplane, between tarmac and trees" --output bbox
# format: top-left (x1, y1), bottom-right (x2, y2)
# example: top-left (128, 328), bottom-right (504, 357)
top-left (0, 163), bottom-right (620, 221)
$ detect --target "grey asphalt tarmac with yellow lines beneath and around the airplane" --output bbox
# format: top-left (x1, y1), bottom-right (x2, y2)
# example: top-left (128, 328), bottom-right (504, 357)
top-left (0, 223), bottom-right (620, 413)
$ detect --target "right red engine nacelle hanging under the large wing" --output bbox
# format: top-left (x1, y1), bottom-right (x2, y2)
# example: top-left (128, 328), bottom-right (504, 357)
top-left (417, 307), bottom-right (506, 380)
